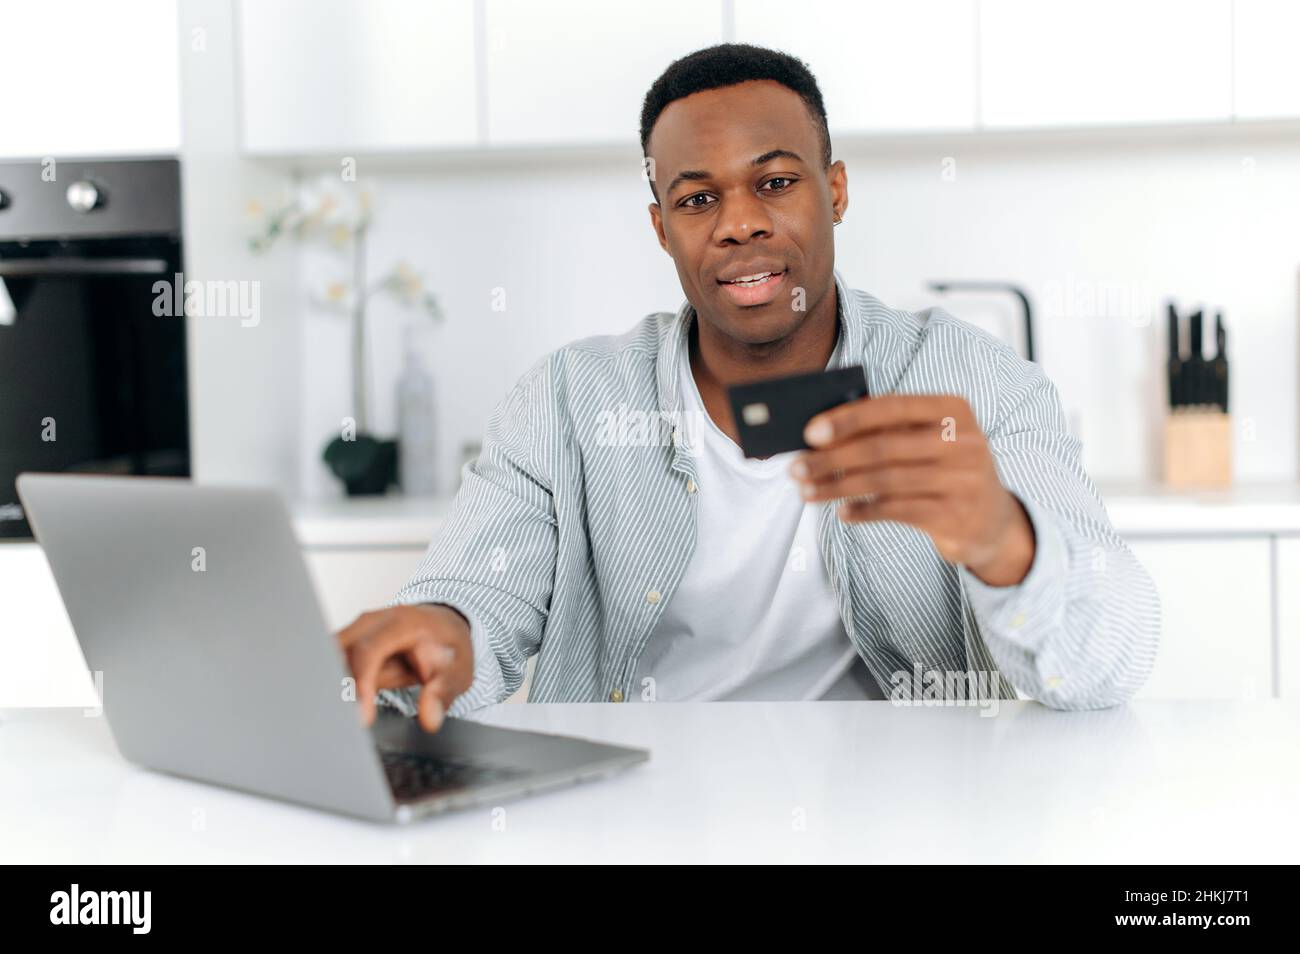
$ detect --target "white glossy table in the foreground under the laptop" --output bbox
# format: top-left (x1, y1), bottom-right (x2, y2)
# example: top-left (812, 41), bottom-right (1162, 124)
top-left (0, 701), bottom-right (1300, 863)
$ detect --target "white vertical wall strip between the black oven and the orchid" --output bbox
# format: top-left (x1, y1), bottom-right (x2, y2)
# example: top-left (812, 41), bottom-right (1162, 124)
top-left (179, 0), bottom-right (302, 489)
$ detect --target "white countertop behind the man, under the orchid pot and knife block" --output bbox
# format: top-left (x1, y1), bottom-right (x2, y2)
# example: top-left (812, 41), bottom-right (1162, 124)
top-left (290, 481), bottom-right (1300, 550)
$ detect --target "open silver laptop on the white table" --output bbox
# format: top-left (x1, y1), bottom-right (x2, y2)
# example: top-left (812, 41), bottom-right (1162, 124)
top-left (18, 473), bottom-right (650, 821)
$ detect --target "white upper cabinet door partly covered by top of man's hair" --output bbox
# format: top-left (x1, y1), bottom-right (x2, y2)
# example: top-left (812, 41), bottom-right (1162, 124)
top-left (484, 0), bottom-right (722, 147)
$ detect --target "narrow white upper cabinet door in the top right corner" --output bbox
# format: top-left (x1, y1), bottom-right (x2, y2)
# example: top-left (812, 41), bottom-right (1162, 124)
top-left (1232, 0), bottom-right (1300, 120)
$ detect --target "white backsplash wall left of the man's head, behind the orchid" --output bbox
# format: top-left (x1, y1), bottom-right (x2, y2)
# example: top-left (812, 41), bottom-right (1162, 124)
top-left (291, 157), bottom-right (681, 495)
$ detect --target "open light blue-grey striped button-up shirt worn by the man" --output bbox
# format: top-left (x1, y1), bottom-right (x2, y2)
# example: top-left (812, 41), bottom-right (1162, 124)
top-left (384, 265), bottom-right (1160, 716)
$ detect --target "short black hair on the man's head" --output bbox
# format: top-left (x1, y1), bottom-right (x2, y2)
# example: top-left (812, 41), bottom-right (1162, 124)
top-left (641, 43), bottom-right (831, 200)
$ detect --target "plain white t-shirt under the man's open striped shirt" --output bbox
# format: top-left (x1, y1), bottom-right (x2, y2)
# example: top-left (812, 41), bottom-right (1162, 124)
top-left (632, 332), bottom-right (883, 702)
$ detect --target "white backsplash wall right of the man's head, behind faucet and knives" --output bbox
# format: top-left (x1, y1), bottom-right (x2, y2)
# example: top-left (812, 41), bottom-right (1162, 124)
top-left (839, 129), bottom-right (1300, 480)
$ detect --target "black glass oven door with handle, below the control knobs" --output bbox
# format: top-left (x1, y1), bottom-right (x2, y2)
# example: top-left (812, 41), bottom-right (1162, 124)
top-left (0, 238), bottom-right (190, 538)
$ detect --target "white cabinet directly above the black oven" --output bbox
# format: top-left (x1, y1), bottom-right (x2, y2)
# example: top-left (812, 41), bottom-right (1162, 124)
top-left (0, 0), bottom-right (182, 159)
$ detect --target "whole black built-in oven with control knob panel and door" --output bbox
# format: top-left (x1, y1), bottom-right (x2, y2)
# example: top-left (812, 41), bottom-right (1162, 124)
top-left (0, 159), bottom-right (190, 538)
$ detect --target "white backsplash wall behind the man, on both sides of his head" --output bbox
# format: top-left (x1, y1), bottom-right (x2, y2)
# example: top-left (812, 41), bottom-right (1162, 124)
top-left (292, 133), bottom-right (1300, 494)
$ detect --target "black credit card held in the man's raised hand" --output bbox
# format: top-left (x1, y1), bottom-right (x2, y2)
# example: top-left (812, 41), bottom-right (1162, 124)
top-left (727, 364), bottom-right (867, 458)
